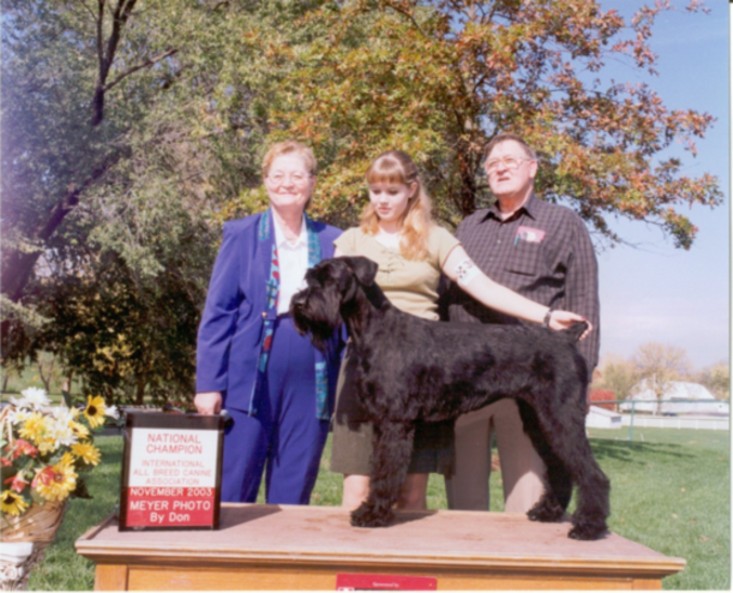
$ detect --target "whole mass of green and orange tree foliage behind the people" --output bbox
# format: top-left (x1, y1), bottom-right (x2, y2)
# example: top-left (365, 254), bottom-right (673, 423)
top-left (1, 0), bottom-right (722, 402)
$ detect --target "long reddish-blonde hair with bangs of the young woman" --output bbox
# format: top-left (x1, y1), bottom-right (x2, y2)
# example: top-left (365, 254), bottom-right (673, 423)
top-left (360, 150), bottom-right (433, 260)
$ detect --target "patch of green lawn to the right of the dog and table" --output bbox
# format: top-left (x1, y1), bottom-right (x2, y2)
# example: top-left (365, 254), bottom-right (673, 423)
top-left (591, 429), bottom-right (731, 590)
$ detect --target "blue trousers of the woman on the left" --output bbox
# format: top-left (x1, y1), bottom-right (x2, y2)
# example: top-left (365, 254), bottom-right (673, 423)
top-left (222, 316), bottom-right (329, 504)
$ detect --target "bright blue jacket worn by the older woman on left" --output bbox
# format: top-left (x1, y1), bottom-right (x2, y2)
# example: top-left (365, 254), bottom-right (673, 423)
top-left (196, 212), bottom-right (342, 417)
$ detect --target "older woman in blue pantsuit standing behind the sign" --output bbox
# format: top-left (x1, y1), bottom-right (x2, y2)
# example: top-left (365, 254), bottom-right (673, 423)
top-left (194, 141), bottom-right (341, 504)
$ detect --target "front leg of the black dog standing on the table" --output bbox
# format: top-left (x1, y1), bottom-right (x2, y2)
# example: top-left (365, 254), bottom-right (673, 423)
top-left (351, 421), bottom-right (415, 527)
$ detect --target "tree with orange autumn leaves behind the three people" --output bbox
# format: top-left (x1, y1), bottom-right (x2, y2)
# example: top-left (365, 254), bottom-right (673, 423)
top-left (237, 0), bottom-right (721, 248)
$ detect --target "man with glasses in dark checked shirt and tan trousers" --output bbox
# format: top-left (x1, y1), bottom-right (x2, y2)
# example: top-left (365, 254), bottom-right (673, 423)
top-left (446, 134), bottom-right (600, 513)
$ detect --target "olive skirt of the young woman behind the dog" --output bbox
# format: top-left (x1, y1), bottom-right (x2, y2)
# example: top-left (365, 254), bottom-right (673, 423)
top-left (331, 349), bottom-right (454, 476)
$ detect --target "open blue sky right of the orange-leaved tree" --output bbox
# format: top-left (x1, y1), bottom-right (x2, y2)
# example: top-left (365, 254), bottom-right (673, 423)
top-left (598, 0), bottom-right (731, 369)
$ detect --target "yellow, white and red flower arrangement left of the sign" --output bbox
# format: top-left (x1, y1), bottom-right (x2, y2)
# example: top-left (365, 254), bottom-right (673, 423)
top-left (0, 387), bottom-right (118, 517)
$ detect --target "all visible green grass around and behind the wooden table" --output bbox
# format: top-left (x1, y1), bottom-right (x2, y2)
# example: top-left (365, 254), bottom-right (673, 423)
top-left (28, 429), bottom-right (731, 590)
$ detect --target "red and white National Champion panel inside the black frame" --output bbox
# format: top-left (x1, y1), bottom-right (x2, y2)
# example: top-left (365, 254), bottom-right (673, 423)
top-left (122, 427), bottom-right (219, 528)
